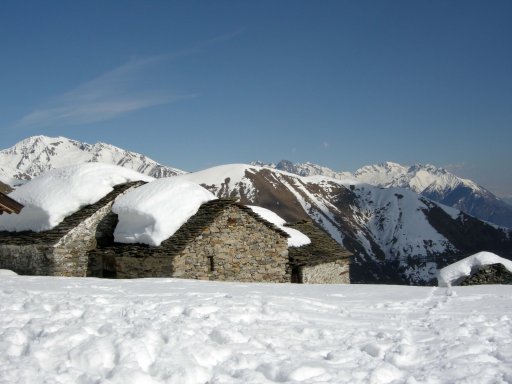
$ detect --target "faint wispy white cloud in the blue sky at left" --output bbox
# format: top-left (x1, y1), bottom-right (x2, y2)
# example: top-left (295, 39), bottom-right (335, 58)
top-left (15, 56), bottom-right (196, 127)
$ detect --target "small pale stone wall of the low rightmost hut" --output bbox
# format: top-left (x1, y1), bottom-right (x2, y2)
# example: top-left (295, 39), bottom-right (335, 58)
top-left (299, 259), bottom-right (350, 284)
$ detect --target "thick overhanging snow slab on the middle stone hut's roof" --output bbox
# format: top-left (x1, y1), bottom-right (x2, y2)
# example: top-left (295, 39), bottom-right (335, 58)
top-left (112, 177), bottom-right (216, 246)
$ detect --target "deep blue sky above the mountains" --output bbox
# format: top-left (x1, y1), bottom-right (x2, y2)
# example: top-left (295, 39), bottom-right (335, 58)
top-left (0, 0), bottom-right (512, 196)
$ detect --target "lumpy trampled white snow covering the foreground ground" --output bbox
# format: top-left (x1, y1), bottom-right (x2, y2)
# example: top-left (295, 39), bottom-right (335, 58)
top-left (0, 273), bottom-right (512, 384)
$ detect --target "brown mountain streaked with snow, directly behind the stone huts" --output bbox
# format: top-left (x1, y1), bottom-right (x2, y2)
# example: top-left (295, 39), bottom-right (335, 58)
top-left (179, 164), bottom-right (512, 284)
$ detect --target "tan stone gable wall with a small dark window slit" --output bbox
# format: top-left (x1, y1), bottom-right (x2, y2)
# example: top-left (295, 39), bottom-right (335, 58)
top-left (173, 206), bottom-right (290, 282)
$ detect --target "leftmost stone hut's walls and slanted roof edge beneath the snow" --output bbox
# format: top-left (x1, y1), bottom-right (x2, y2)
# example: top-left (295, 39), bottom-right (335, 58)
top-left (0, 182), bottom-right (144, 276)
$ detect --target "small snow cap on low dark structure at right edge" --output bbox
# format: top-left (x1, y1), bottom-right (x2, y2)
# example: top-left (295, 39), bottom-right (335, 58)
top-left (437, 252), bottom-right (512, 287)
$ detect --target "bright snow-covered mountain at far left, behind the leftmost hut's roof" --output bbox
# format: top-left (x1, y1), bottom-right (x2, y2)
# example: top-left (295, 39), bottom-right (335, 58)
top-left (0, 136), bottom-right (184, 185)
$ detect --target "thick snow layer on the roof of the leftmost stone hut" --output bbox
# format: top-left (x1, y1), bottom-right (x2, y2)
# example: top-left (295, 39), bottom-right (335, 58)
top-left (0, 163), bottom-right (153, 232)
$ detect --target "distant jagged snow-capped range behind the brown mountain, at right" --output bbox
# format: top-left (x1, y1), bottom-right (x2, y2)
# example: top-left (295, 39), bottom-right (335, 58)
top-left (253, 160), bottom-right (512, 228)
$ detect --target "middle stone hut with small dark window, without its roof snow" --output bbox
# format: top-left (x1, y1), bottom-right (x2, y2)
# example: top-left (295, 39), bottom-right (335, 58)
top-left (89, 199), bottom-right (291, 282)
